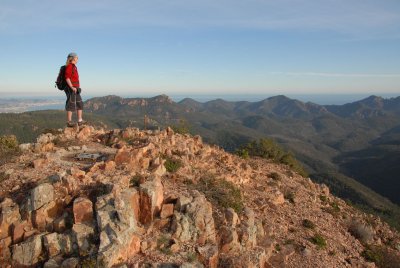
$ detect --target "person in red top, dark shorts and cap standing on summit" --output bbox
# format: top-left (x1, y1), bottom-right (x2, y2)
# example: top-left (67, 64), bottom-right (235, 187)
top-left (64, 52), bottom-right (86, 127)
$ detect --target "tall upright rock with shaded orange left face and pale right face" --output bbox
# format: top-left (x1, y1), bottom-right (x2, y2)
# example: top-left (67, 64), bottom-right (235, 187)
top-left (139, 176), bottom-right (164, 224)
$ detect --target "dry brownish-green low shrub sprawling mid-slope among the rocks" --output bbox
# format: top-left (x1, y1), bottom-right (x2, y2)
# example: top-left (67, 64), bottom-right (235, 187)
top-left (191, 174), bottom-right (243, 213)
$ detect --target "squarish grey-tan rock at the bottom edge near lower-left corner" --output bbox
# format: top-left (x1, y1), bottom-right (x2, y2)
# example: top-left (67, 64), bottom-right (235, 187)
top-left (12, 235), bottom-right (42, 266)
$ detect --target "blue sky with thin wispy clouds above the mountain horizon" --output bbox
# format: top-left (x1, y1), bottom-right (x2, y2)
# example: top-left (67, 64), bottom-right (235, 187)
top-left (0, 0), bottom-right (400, 96)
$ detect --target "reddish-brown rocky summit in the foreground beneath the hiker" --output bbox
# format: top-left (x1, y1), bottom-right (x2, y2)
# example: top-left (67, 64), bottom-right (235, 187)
top-left (0, 126), bottom-right (400, 268)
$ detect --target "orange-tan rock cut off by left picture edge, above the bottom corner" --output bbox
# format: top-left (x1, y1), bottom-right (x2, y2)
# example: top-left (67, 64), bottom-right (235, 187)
top-left (0, 198), bottom-right (21, 239)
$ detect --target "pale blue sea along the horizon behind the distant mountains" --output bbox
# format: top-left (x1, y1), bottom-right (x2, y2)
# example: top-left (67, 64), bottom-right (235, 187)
top-left (0, 92), bottom-right (400, 112)
